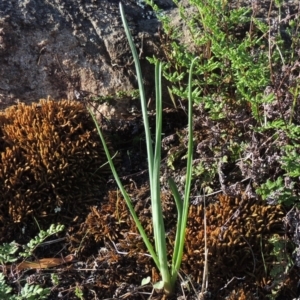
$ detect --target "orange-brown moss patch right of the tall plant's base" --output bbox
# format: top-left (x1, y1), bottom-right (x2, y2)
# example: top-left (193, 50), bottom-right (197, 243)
top-left (182, 195), bottom-right (284, 288)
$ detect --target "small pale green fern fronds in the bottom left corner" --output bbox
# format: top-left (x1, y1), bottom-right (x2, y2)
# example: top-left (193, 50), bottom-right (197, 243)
top-left (0, 224), bottom-right (64, 300)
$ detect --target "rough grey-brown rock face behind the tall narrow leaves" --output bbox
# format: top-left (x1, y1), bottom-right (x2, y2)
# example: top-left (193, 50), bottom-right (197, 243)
top-left (0, 0), bottom-right (176, 109)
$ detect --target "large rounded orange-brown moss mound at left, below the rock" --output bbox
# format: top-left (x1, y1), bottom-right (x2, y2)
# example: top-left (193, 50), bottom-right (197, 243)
top-left (0, 100), bottom-right (108, 240)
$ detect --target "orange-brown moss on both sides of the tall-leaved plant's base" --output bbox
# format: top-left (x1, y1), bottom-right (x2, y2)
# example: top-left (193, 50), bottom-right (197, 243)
top-left (82, 188), bottom-right (284, 299)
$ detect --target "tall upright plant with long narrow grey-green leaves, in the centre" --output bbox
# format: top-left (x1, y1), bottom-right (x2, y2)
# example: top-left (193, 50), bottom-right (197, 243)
top-left (90, 3), bottom-right (196, 295)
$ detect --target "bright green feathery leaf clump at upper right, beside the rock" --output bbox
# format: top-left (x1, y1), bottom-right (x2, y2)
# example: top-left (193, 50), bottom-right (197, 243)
top-left (150, 0), bottom-right (272, 121)
